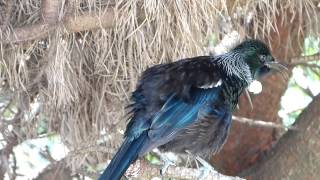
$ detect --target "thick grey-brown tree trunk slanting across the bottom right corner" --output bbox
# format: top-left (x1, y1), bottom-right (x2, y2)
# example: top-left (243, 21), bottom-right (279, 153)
top-left (243, 94), bottom-right (320, 180)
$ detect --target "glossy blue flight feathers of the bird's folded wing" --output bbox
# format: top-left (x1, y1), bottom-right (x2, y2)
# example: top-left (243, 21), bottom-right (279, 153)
top-left (136, 88), bottom-right (225, 154)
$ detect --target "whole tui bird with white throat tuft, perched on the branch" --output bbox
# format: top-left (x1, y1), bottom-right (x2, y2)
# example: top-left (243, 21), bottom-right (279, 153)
top-left (100, 39), bottom-right (285, 180)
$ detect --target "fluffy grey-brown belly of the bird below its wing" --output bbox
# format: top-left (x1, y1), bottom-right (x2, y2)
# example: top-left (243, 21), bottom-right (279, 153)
top-left (159, 100), bottom-right (231, 156)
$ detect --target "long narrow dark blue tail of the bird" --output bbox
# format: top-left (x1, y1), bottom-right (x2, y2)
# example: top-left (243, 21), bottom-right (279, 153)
top-left (99, 132), bottom-right (148, 180)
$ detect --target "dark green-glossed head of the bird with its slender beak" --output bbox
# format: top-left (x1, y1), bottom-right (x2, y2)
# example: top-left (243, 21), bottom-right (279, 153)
top-left (233, 40), bottom-right (287, 79)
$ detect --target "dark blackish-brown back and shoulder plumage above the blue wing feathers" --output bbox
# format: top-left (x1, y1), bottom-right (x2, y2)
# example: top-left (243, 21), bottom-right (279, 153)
top-left (139, 56), bottom-right (220, 101)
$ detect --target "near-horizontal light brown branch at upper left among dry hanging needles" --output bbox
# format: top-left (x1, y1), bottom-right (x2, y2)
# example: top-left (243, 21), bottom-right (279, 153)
top-left (0, 8), bottom-right (115, 44)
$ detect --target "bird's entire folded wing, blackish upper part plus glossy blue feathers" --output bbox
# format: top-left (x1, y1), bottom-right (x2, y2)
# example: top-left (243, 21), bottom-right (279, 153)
top-left (126, 56), bottom-right (221, 142)
